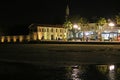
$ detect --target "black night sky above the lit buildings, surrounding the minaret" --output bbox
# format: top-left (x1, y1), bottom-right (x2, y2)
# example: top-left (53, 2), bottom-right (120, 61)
top-left (0, 0), bottom-right (120, 34)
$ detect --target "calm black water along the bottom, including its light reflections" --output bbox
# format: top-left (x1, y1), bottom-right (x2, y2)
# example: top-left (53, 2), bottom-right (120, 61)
top-left (0, 62), bottom-right (120, 80)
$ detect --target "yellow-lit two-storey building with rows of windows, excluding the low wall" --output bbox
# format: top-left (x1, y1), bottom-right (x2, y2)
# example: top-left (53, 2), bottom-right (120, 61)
top-left (29, 24), bottom-right (67, 40)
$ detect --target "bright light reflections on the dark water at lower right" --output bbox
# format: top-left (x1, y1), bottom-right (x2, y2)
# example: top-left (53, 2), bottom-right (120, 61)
top-left (66, 65), bottom-right (120, 80)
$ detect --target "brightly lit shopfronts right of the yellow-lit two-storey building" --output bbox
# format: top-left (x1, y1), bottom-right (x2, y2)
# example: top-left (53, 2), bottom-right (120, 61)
top-left (68, 23), bottom-right (120, 41)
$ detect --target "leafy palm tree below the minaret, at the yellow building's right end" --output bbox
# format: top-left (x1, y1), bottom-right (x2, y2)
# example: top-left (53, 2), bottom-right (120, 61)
top-left (63, 16), bottom-right (87, 39)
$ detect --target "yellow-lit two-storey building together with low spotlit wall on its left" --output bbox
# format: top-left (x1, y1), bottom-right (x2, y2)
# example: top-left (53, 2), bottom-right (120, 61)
top-left (0, 24), bottom-right (67, 43)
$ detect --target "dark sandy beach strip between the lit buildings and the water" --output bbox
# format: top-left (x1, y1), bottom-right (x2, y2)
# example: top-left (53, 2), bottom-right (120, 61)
top-left (0, 42), bottom-right (120, 66)
